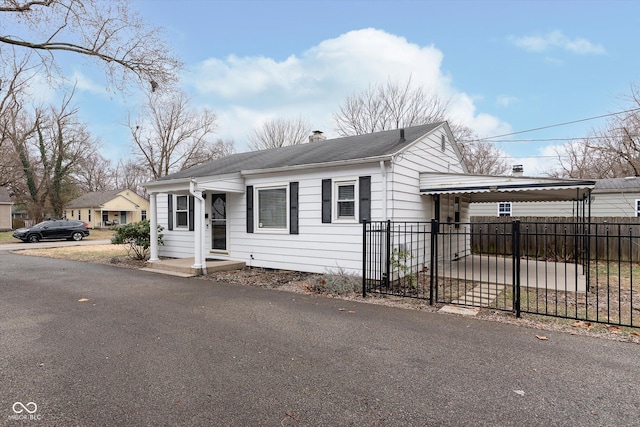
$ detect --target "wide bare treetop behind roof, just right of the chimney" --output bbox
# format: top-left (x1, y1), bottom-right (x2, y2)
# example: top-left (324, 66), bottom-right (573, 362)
top-left (333, 78), bottom-right (448, 136)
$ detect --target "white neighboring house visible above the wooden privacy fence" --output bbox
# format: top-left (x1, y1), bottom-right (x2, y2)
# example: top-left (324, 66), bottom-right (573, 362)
top-left (470, 177), bottom-right (640, 218)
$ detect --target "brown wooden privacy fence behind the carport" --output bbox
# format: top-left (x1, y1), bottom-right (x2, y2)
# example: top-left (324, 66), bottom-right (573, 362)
top-left (471, 216), bottom-right (640, 261)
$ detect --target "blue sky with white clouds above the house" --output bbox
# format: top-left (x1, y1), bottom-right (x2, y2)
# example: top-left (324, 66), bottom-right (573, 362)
top-left (51, 0), bottom-right (640, 175)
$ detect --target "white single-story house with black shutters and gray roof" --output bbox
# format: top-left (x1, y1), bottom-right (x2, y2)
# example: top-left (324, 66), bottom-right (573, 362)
top-left (144, 122), bottom-right (596, 273)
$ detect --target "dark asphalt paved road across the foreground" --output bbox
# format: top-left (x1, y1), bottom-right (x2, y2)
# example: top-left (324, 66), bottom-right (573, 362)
top-left (0, 252), bottom-right (640, 426)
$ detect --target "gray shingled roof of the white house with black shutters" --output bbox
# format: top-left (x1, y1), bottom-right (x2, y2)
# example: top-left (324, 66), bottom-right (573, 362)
top-left (158, 122), bottom-right (444, 181)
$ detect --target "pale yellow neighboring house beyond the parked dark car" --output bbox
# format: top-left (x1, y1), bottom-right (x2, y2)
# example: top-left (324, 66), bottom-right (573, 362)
top-left (64, 190), bottom-right (149, 228)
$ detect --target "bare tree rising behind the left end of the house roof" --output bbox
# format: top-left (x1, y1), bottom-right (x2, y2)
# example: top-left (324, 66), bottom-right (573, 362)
top-left (127, 93), bottom-right (224, 179)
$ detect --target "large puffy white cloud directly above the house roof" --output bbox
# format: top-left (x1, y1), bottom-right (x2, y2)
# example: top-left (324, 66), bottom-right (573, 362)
top-left (185, 28), bottom-right (510, 150)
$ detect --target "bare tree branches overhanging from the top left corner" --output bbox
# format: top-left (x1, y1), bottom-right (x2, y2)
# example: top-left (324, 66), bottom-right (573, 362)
top-left (0, 0), bottom-right (181, 90)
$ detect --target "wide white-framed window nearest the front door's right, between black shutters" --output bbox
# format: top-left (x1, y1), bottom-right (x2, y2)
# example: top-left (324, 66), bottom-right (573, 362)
top-left (255, 185), bottom-right (289, 232)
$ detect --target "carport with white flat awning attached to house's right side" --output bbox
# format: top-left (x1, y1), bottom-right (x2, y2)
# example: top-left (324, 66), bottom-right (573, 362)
top-left (420, 173), bottom-right (595, 300)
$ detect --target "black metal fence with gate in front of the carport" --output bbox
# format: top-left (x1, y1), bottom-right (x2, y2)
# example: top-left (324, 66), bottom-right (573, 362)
top-left (363, 220), bottom-right (640, 327)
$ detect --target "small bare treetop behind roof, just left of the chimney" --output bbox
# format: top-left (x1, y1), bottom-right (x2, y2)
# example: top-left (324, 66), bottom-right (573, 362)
top-left (249, 117), bottom-right (311, 150)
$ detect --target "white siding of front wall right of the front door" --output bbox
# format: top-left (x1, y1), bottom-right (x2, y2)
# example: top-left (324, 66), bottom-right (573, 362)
top-left (227, 164), bottom-right (382, 274)
